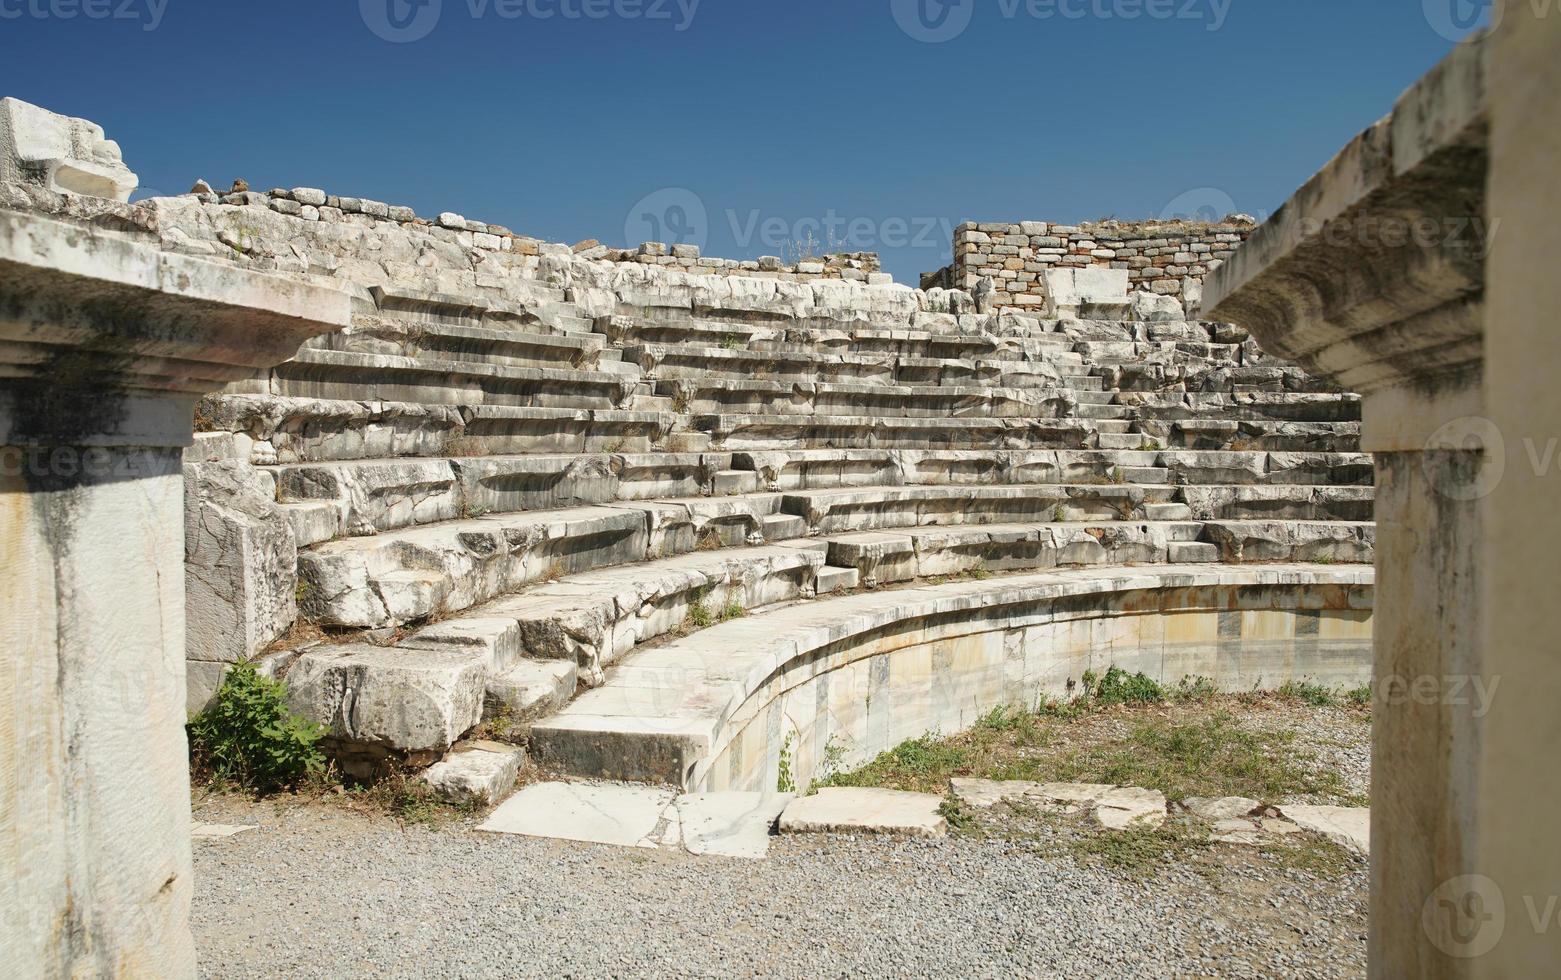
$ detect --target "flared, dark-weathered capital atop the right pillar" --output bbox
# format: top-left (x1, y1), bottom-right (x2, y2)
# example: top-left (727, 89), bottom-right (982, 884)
top-left (1204, 34), bottom-right (1495, 401)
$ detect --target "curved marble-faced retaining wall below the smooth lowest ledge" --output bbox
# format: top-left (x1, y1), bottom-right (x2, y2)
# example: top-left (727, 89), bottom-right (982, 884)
top-left (705, 570), bottom-right (1372, 791)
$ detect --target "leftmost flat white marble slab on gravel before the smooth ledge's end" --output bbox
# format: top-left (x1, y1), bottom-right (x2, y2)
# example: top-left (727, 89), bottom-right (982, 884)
top-left (478, 783), bottom-right (677, 847)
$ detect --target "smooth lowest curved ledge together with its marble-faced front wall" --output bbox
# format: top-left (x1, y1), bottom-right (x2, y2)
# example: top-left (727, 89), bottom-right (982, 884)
top-left (531, 565), bottom-right (1372, 791)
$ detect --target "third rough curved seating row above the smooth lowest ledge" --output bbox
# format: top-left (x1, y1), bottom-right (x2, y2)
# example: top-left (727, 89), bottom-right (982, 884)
top-left (268, 449), bottom-right (1372, 546)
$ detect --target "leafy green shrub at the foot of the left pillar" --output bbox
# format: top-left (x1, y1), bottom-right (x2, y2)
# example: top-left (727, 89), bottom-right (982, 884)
top-left (189, 663), bottom-right (325, 793)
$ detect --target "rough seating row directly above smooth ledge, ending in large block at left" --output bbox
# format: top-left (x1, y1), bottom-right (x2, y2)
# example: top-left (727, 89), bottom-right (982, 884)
top-left (278, 521), bottom-right (1371, 772)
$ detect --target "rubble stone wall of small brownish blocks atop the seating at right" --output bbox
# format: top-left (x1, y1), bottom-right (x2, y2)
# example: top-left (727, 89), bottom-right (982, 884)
top-left (924, 215), bottom-right (1255, 309)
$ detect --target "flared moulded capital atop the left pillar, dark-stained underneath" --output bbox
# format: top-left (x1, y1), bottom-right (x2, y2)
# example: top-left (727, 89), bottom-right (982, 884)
top-left (0, 211), bottom-right (351, 446)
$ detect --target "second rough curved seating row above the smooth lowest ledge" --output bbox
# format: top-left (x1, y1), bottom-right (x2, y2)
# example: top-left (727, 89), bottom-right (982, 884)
top-left (298, 484), bottom-right (1371, 629)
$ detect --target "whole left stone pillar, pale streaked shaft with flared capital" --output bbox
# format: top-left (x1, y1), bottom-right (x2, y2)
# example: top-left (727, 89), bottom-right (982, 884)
top-left (0, 204), bottom-right (350, 977)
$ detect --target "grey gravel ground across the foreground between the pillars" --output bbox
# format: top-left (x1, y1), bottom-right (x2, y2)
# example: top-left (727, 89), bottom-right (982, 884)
top-left (194, 797), bottom-right (1366, 978)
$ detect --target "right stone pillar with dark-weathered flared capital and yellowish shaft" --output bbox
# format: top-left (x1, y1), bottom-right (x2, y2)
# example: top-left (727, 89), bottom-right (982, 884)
top-left (1205, 36), bottom-right (1492, 980)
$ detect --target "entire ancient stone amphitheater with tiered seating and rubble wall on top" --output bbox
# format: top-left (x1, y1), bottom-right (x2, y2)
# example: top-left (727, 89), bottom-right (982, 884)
top-left (42, 170), bottom-right (1336, 790)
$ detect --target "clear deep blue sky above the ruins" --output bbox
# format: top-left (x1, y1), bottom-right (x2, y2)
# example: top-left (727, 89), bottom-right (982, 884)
top-left (0, 0), bottom-right (1483, 281)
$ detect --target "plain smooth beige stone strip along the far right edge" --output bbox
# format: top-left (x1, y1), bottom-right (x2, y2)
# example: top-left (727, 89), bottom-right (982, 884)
top-left (1466, 0), bottom-right (1561, 980)
